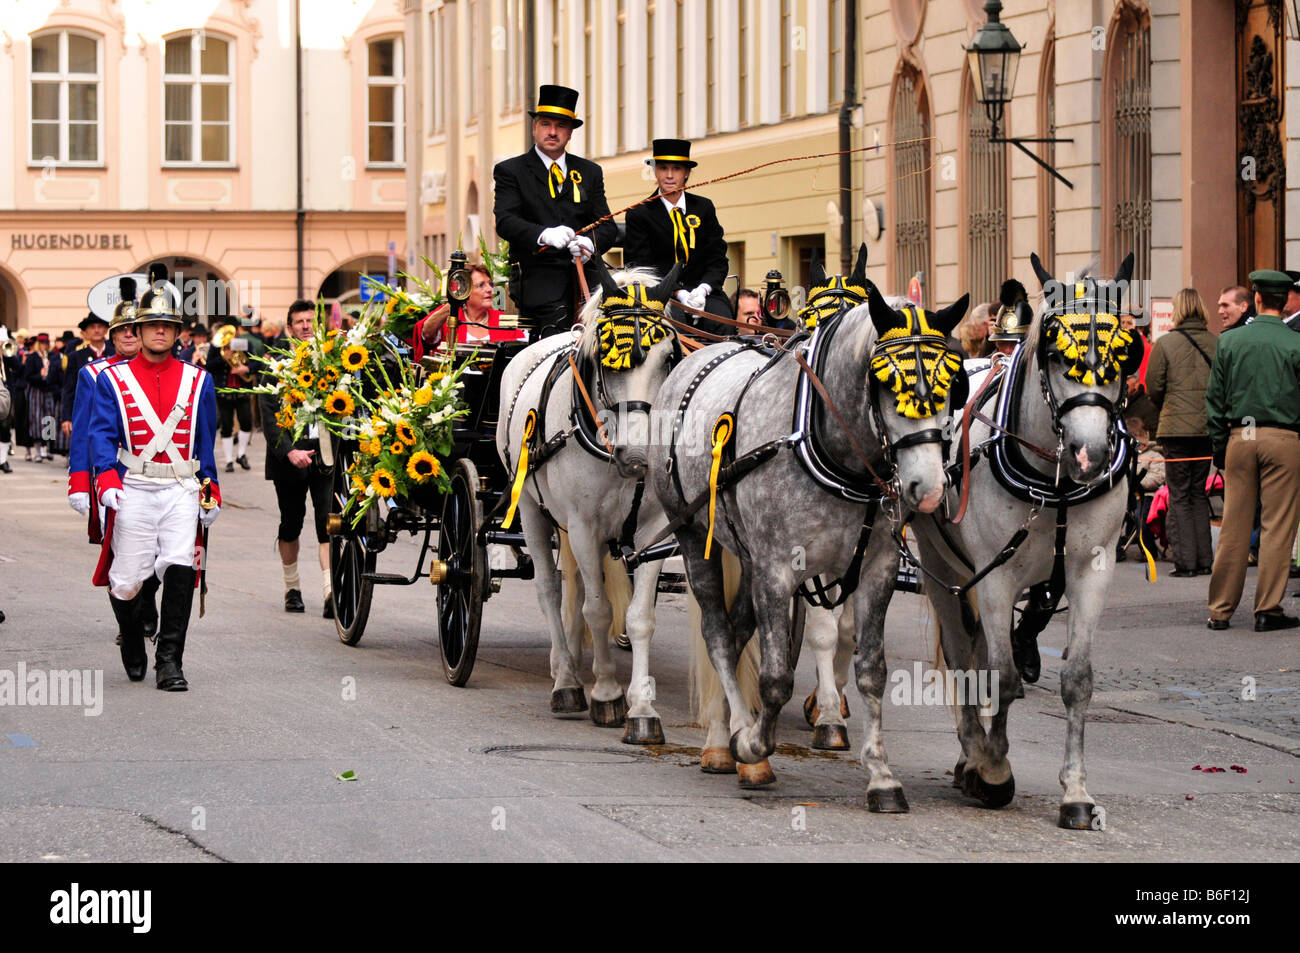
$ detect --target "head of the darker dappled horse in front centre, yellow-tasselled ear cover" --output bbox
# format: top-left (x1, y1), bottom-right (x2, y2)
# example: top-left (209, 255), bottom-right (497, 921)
top-left (867, 294), bottom-right (969, 512)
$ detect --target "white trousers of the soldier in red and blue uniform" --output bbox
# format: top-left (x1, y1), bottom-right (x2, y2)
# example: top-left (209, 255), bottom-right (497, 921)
top-left (108, 476), bottom-right (199, 599)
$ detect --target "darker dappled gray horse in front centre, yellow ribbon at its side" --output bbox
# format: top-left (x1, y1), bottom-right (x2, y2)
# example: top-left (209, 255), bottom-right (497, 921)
top-left (647, 247), bottom-right (966, 811)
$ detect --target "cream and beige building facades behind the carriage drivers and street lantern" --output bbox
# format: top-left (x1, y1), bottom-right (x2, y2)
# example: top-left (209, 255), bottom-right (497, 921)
top-left (407, 0), bottom-right (1300, 330)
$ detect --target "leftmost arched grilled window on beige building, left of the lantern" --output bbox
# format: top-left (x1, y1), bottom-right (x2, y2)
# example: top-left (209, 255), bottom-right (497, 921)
top-left (889, 65), bottom-right (933, 291)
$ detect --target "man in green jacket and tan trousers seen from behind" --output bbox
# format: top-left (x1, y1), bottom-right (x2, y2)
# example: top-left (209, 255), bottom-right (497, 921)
top-left (1205, 270), bottom-right (1300, 632)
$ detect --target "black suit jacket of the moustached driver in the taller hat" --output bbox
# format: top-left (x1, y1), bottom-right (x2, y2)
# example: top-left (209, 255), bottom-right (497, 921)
top-left (493, 150), bottom-right (618, 315)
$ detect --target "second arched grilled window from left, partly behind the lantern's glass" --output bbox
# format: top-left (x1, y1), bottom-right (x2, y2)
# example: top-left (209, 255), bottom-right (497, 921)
top-left (962, 70), bottom-right (1010, 304)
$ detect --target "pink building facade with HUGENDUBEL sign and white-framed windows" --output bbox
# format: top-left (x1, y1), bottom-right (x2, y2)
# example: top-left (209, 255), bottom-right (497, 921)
top-left (0, 0), bottom-right (407, 333)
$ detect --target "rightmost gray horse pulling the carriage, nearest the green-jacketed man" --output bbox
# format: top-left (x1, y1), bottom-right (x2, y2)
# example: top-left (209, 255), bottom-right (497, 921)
top-left (914, 255), bottom-right (1144, 829)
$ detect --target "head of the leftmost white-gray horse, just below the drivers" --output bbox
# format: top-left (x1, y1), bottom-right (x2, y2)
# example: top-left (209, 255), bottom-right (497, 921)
top-left (576, 257), bottom-right (681, 477)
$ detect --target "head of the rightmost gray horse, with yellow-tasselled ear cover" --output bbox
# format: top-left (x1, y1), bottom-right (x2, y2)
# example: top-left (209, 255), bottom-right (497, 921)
top-left (1027, 254), bottom-right (1145, 484)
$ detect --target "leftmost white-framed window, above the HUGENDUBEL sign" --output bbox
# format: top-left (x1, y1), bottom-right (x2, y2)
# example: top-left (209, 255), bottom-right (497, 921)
top-left (29, 30), bottom-right (104, 165)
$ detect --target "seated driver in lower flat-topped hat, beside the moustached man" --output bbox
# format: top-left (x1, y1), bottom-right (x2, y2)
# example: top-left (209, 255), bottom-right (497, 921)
top-left (623, 139), bottom-right (733, 334)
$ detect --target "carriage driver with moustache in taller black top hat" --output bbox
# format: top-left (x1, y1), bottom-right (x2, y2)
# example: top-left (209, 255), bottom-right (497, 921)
top-left (493, 86), bottom-right (618, 341)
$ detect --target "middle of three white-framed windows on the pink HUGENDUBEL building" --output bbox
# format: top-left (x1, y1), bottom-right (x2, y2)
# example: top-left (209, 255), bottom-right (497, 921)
top-left (163, 30), bottom-right (235, 165)
